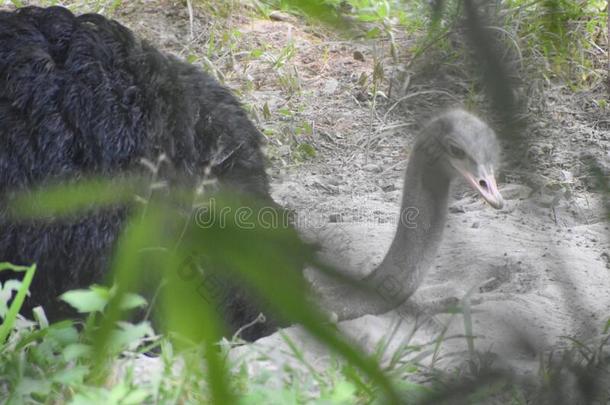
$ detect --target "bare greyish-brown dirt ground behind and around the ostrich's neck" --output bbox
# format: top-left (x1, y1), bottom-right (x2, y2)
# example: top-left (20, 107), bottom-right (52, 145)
top-left (5, 1), bottom-right (610, 386)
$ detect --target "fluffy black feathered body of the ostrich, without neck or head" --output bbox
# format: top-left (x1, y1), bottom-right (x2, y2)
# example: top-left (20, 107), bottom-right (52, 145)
top-left (0, 7), bottom-right (275, 339)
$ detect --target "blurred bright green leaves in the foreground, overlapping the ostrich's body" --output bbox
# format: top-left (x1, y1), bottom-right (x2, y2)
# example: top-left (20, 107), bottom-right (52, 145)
top-left (3, 179), bottom-right (399, 403)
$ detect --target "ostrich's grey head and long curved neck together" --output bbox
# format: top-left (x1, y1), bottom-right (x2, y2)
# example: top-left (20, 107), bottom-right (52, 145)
top-left (313, 110), bottom-right (503, 320)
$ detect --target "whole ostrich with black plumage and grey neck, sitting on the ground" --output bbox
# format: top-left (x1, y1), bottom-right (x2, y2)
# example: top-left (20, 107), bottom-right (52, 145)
top-left (0, 7), bottom-right (502, 340)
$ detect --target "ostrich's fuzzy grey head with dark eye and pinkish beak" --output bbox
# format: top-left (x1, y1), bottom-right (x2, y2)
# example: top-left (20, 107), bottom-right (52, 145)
top-left (420, 110), bottom-right (504, 209)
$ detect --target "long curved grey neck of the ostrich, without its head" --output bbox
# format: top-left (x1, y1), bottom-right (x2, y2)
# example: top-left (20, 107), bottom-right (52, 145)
top-left (322, 148), bottom-right (450, 320)
